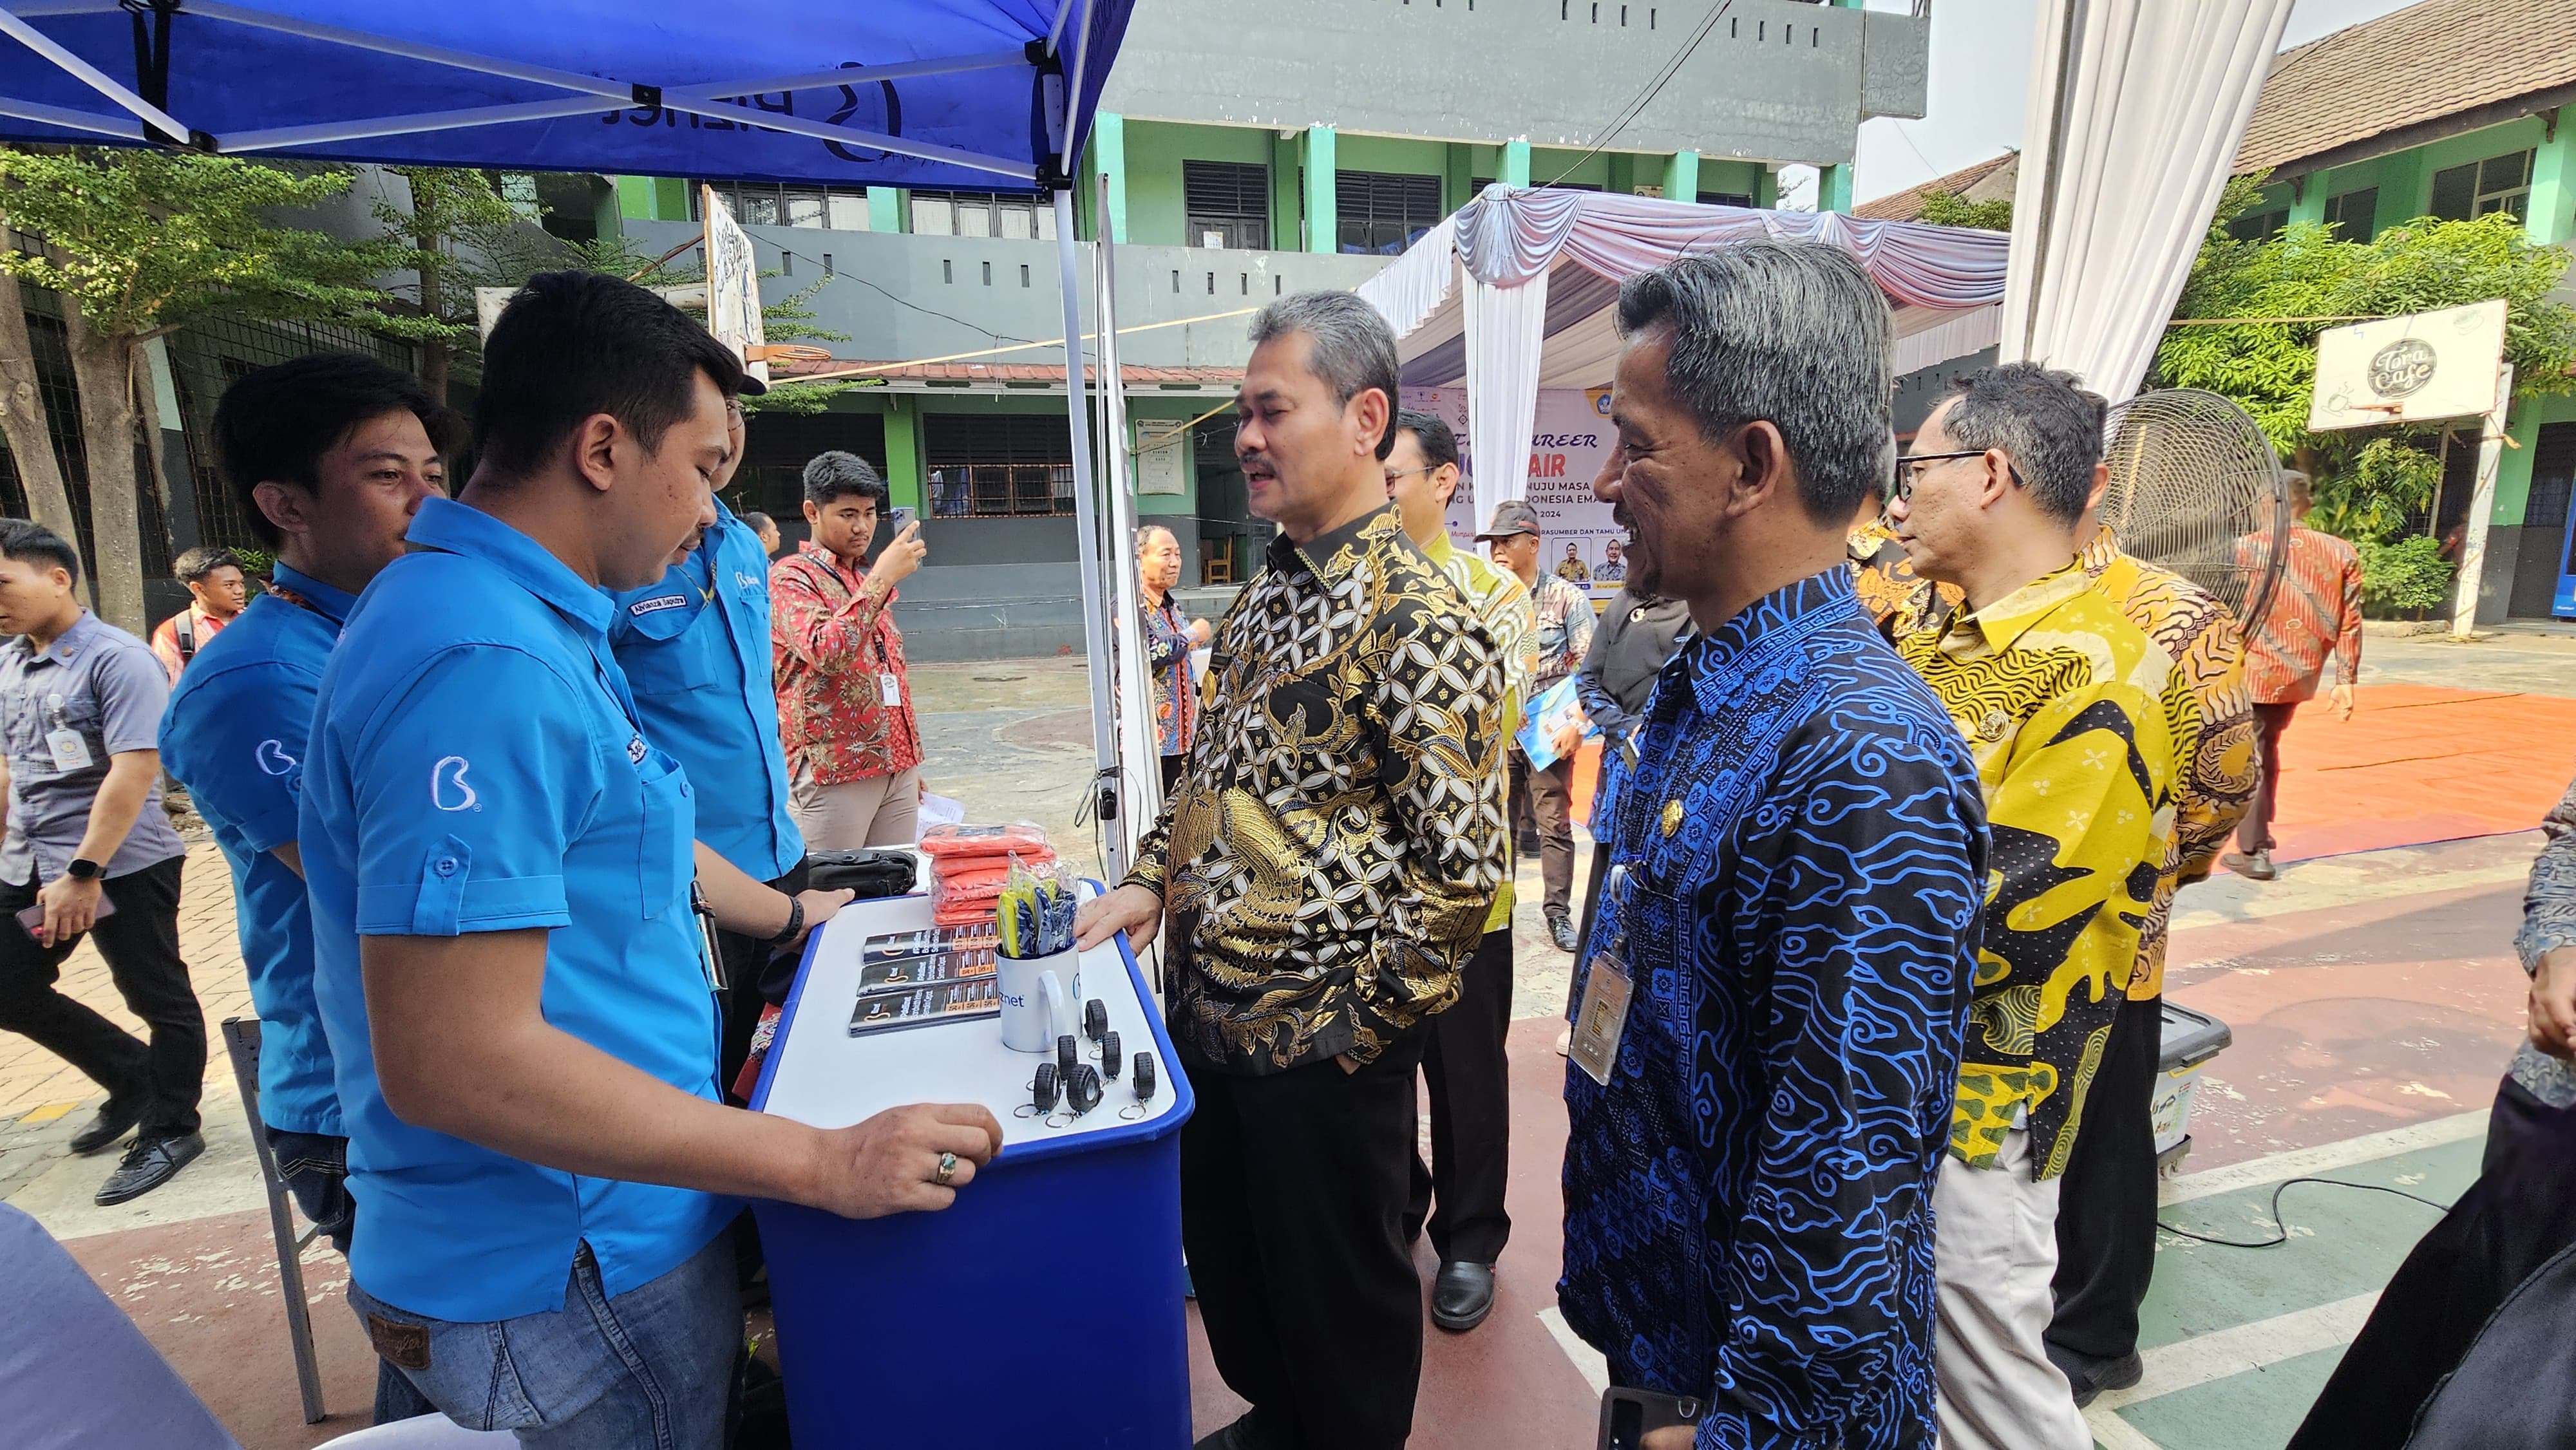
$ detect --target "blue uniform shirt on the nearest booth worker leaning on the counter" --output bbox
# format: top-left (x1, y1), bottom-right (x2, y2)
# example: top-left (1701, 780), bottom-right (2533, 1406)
top-left (296, 500), bottom-right (734, 1321)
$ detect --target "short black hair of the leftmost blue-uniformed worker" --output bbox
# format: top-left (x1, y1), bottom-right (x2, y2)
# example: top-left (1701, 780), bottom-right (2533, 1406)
top-left (214, 353), bottom-right (464, 549)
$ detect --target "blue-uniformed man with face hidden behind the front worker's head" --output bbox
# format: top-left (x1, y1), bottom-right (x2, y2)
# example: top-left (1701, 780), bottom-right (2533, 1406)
top-left (608, 402), bottom-right (848, 1102)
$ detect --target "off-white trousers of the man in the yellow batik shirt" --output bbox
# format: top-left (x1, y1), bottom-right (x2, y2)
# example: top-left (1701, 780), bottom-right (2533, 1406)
top-left (1932, 1128), bottom-right (2092, 1450)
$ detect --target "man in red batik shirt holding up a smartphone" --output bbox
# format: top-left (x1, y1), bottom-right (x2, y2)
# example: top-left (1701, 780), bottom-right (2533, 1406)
top-left (770, 451), bottom-right (930, 850)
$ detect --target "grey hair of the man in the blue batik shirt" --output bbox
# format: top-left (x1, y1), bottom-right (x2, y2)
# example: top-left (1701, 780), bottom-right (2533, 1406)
top-left (1618, 242), bottom-right (1896, 523)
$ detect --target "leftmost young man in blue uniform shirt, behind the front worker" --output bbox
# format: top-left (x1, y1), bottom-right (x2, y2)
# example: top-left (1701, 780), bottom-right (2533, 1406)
top-left (160, 353), bottom-right (461, 1424)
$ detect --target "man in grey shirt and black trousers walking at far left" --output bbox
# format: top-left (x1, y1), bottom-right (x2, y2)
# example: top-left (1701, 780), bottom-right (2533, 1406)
top-left (0, 518), bottom-right (206, 1208)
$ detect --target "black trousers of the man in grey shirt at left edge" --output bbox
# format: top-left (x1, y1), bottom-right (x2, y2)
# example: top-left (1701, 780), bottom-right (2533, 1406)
top-left (0, 855), bottom-right (206, 1138)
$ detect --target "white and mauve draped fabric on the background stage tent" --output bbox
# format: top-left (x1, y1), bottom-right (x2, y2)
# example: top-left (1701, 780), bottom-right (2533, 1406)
top-left (1360, 185), bottom-right (2007, 507)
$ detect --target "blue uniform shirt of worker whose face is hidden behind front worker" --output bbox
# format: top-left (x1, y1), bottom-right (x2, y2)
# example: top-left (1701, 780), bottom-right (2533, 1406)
top-left (608, 500), bottom-right (804, 881)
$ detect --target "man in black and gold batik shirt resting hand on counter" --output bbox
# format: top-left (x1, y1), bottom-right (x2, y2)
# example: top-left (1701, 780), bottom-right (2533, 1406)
top-left (1079, 294), bottom-right (1507, 1450)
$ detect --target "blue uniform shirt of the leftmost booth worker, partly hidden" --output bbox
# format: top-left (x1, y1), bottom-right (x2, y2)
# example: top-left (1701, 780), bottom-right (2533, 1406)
top-left (160, 564), bottom-right (358, 1136)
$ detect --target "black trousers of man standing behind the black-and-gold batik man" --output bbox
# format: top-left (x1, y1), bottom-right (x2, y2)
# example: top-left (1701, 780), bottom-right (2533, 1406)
top-left (1404, 927), bottom-right (1512, 1265)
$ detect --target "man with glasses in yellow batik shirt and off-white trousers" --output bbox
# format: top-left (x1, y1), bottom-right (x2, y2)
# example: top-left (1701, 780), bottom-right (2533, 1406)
top-left (1888, 363), bottom-right (2174, 1450)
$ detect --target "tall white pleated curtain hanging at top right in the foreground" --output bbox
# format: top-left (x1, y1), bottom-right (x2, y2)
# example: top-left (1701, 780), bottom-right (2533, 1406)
top-left (2002, 0), bottom-right (2290, 402)
